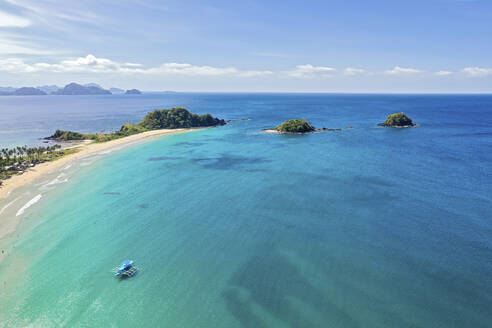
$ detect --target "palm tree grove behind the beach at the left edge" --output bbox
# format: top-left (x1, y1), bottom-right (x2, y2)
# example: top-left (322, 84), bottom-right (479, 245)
top-left (0, 145), bottom-right (79, 186)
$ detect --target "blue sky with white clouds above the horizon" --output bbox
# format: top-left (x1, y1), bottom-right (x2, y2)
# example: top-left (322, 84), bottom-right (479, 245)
top-left (0, 0), bottom-right (492, 93)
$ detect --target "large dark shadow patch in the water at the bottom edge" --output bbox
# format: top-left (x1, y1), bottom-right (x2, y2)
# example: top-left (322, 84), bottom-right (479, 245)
top-left (222, 247), bottom-right (359, 328)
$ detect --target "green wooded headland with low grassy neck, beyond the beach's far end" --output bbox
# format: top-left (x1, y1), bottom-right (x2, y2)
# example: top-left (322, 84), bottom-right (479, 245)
top-left (46, 107), bottom-right (226, 142)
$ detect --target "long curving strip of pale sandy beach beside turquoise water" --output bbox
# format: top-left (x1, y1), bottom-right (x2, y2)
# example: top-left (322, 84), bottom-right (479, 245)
top-left (0, 129), bottom-right (196, 243)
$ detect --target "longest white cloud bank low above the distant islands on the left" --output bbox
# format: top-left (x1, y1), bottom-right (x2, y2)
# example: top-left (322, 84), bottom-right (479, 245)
top-left (0, 54), bottom-right (272, 77)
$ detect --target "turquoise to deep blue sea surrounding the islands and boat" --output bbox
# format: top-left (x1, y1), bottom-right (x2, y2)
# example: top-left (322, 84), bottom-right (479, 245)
top-left (0, 93), bottom-right (492, 328)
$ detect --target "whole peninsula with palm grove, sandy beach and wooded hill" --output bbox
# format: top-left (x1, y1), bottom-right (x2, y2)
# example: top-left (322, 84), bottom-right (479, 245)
top-left (0, 107), bottom-right (226, 196)
